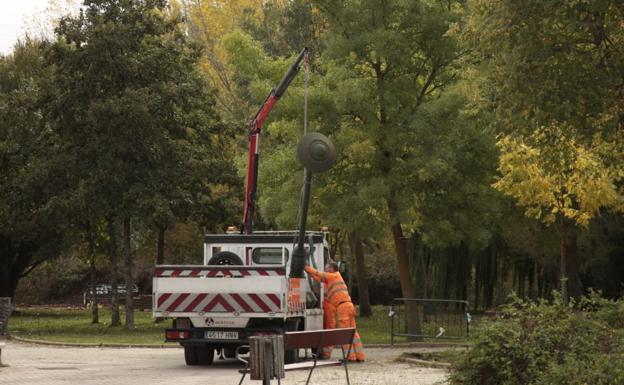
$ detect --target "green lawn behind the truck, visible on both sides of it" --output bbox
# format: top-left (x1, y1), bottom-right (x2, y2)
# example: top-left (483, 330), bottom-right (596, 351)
top-left (9, 306), bottom-right (472, 345)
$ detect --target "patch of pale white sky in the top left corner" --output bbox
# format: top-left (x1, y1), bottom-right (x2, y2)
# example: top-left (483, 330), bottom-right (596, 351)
top-left (0, 0), bottom-right (77, 55)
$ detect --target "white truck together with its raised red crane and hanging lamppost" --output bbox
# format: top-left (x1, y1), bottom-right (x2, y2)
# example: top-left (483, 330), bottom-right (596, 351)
top-left (153, 48), bottom-right (336, 365)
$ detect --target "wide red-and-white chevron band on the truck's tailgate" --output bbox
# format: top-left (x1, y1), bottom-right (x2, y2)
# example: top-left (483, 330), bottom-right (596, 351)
top-left (156, 293), bottom-right (281, 313)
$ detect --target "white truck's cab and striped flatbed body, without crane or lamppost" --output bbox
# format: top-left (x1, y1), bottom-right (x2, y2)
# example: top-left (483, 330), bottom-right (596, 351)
top-left (153, 232), bottom-right (329, 365)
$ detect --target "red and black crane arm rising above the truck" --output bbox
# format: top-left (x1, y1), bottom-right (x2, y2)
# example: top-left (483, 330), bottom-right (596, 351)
top-left (241, 47), bottom-right (309, 234)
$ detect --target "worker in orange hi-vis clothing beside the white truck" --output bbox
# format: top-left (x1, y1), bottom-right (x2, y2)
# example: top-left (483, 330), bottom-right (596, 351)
top-left (305, 261), bottom-right (365, 361)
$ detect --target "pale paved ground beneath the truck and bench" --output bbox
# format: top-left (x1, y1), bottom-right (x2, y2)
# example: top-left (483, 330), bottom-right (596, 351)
top-left (0, 341), bottom-right (446, 385)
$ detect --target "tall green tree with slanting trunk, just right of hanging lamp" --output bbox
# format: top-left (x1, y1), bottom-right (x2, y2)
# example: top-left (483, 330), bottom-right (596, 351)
top-left (319, 0), bottom-right (500, 332)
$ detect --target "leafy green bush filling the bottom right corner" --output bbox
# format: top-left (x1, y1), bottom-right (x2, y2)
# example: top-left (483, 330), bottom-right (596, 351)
top-left (450, 295), bottom-right (624, 385)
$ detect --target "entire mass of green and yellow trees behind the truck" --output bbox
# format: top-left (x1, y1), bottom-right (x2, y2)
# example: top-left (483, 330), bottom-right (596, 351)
top-left (0, 0), bottom-right (624, 316)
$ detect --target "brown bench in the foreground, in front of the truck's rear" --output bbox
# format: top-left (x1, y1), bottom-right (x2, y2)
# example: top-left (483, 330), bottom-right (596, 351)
top-left (236, 328), bottom-right (355, 385)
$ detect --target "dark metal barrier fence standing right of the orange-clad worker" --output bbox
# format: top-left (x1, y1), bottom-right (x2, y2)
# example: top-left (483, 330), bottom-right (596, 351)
top-left (388, 298), bottom-right (472, 344)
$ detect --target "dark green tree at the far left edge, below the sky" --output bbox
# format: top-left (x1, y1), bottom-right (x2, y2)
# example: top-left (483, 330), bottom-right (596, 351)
top-left (0, 39), bottom-right (69, 297)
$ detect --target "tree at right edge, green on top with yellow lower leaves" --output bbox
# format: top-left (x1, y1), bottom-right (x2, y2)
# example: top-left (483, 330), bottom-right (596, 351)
top-left (467, 0), bottom-right (624, 300)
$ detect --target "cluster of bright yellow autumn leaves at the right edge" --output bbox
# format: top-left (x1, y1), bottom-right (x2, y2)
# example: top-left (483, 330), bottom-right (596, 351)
top-left (494, 126), bottom-right (624, 226)
